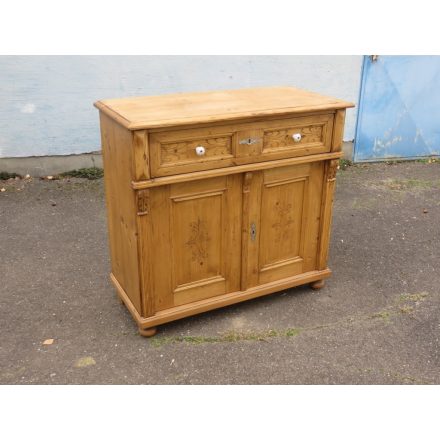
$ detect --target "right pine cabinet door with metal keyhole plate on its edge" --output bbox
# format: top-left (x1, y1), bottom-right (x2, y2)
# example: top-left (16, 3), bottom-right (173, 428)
top-left (242, 162), bottom-right (324, 290)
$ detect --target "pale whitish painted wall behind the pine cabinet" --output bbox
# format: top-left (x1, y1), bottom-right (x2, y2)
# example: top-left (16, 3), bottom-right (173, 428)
top-left (0, 56), bottom-right (362, 157)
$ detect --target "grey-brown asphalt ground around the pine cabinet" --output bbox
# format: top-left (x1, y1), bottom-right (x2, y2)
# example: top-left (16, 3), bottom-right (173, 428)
top-left (0, 162), bottom-right (440, 384)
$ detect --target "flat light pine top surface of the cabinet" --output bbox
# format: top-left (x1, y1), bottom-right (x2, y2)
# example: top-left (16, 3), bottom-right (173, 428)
top-left (94, 87), bottom-right (354, 130)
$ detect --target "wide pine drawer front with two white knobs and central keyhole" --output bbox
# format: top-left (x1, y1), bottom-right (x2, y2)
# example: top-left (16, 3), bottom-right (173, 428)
top-left (150, 114), bottom-right (334, 177)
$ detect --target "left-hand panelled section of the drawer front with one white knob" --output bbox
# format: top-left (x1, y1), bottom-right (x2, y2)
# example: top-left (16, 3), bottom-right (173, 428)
top-left (150, 129), bottom-right (234, 177)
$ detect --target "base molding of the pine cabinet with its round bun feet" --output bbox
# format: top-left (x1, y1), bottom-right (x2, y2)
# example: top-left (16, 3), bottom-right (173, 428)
top-left (110, 268), bottom-right (332, 337)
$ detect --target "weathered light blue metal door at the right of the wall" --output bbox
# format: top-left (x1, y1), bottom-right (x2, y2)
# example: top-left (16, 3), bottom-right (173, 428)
top-left (354, 55), bottom-right (440, 162)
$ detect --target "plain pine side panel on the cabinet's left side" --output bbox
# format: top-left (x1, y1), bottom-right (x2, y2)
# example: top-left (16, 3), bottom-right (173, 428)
top-left (100, 113), bottom-right (141, 313)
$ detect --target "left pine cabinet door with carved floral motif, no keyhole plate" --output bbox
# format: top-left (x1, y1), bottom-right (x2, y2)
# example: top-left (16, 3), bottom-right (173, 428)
top-left (147, 174), bottom-right (242, 311)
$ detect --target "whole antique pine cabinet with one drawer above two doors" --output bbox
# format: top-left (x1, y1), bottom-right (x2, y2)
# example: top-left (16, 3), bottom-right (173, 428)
top-left (95, 87), bottom-right (353, 336)
